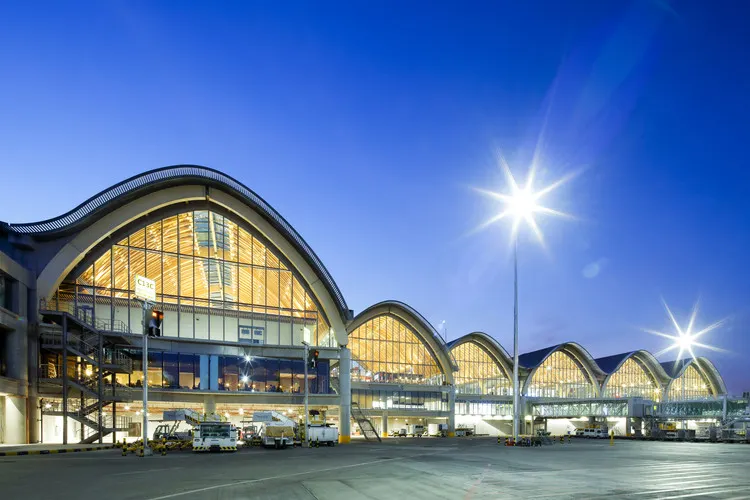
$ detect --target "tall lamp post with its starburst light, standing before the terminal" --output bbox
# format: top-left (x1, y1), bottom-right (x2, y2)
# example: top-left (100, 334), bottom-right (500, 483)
top-left (477, 158), bottom-right (577, 442)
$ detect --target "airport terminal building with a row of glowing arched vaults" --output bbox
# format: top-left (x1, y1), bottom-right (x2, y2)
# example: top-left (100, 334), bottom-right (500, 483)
top-left (0, 166), bottom-right (745, 443)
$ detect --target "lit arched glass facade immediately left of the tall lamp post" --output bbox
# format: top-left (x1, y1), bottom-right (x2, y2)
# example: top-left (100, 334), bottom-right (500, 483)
top-left (451, 342), bottom-right (513, 396)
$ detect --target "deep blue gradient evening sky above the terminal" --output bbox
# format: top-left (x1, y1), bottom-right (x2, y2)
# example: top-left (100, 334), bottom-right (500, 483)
top-left (0, 0), bottom-right (750, 392)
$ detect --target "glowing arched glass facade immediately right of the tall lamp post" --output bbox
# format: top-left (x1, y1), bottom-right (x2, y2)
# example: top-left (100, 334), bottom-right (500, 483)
top-left (526, 351), bottom-right (596, 398)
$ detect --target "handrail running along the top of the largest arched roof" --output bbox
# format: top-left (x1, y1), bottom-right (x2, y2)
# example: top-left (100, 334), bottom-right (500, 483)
top-left (14, 165), bottom-right (349, 316)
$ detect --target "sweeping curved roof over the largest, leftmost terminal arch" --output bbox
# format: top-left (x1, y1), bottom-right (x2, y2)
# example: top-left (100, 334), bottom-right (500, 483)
top-left (6, 165), bottom-right (351, 320)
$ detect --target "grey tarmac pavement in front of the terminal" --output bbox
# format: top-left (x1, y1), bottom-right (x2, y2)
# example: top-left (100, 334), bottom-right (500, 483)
top-left (0, 438), bottom-right (750, 500)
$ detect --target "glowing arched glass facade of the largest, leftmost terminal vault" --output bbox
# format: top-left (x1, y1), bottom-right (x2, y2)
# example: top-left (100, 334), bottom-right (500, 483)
top-left (51, 210), bottom-right (336, 347)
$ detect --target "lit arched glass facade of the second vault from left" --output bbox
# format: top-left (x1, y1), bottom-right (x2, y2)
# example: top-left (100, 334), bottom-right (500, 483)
top-left (349, 315), bottom-right (445, 385)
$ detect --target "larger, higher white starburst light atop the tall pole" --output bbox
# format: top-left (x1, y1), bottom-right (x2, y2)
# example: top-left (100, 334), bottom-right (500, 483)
top-left (475, 157), bottom-right (578, 245)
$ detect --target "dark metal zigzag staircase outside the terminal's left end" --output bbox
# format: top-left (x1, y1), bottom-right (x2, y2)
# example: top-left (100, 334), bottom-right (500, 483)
top-left (38, 309), bottom-right (133, 444)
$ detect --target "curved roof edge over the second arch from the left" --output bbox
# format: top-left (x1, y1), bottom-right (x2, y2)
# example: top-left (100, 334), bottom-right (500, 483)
top-left (346, 300), bottom-right (458, 384)
